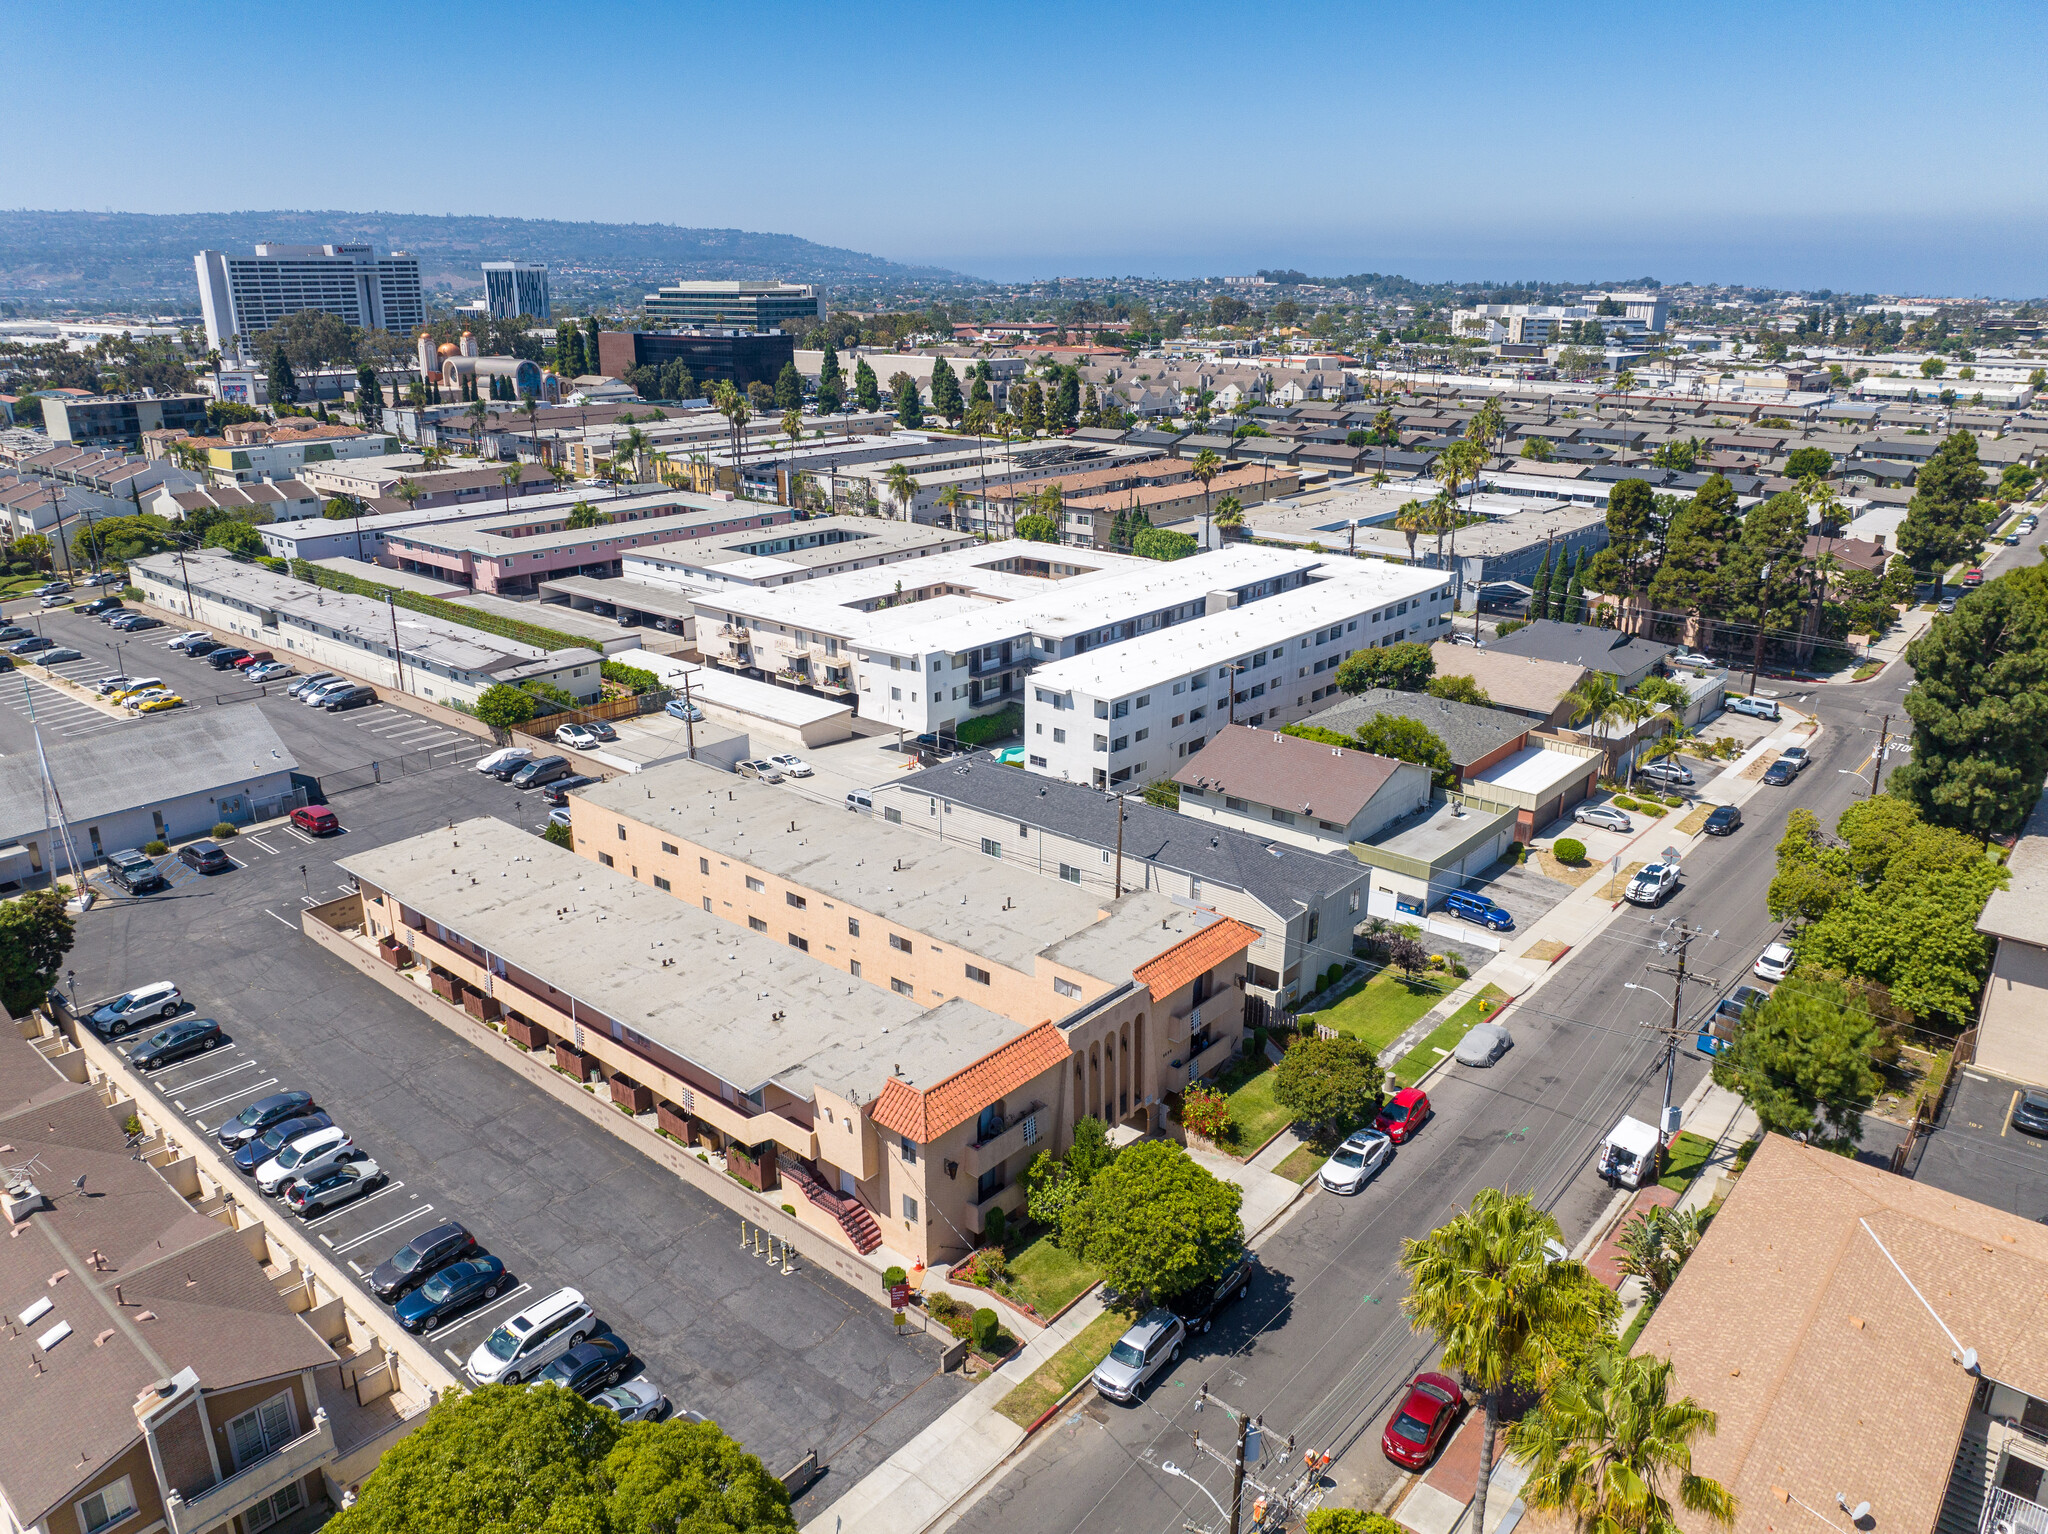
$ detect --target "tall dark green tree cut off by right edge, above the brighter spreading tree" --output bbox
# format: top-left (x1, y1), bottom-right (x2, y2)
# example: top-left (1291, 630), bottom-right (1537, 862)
top-left (1890, 561), bottom-right (2048, 840)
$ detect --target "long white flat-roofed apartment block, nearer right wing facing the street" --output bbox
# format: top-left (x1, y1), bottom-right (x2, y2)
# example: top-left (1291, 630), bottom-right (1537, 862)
top-left (1024, 555), bottom-right (1452, 789)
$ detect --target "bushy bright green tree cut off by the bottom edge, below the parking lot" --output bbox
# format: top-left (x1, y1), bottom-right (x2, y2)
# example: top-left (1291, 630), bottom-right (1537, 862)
top-left (328, 1384), bottom-right (797, 1534)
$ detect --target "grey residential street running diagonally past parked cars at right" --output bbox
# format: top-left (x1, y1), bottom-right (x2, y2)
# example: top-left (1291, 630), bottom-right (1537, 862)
top-left (954, 666), bottom-right (1907, 1534)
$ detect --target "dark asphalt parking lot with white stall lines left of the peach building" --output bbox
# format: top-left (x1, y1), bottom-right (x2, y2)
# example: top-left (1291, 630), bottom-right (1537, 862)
top-left (56, 729), bottom-right (965, 1516)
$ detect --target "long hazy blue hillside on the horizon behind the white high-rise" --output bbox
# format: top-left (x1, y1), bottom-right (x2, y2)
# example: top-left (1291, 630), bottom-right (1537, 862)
top-left (0, 211), bottom-right (963, 311)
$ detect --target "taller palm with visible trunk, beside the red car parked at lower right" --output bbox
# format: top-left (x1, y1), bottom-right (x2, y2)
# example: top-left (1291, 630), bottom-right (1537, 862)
top-left (1401, 1188), bottom-right (1573, 1530)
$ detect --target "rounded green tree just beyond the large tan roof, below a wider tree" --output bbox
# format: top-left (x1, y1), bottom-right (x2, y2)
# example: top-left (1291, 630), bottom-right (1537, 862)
top-left (1714, 975), bottom-right (1884, 1145)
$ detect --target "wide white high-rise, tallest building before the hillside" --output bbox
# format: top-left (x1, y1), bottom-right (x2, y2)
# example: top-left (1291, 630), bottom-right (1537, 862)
top-left (193, 244), bottom-right (426, 352)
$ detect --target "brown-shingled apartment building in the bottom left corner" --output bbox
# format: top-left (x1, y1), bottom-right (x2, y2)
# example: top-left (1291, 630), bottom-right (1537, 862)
top-left (0, 1030), bottom-right (354, 1534)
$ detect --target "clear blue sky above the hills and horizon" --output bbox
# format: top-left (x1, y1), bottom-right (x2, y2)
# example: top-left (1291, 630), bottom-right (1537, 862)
top-left (16, 0), bottom-right (2048, 297)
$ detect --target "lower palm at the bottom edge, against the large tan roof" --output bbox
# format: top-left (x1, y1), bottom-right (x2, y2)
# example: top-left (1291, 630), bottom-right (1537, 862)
top-left (1507, 1348), bottom-right (1735, 1534)
